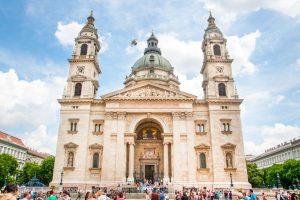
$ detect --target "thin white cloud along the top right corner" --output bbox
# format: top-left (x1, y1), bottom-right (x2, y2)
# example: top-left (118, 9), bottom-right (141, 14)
top-left (201, 0), bottom-right (300, 28)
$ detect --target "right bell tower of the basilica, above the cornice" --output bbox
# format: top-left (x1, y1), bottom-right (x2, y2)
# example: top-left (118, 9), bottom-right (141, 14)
top-left (201, 13), bottom-right (238, 99)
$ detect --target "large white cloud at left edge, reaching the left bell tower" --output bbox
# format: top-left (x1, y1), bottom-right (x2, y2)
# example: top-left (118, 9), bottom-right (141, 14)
top-left (0, 69), bottom-right (65, 126)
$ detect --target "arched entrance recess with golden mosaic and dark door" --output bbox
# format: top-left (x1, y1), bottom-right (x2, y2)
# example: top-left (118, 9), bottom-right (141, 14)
top-left (134, 119), bottom-right (164, 183)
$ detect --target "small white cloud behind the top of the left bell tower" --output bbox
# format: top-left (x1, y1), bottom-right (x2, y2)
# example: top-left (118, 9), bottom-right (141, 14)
top-left (54, 21), bottom-right (111, 53)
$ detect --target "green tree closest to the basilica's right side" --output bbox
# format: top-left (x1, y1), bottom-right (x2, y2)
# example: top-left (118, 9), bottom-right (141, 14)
top-left (247, 163), bottom-right (263, 187)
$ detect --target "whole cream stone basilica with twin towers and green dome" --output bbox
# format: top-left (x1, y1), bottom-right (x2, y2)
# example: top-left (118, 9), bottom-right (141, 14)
top-left (51, 12), bottom-right (251, 188)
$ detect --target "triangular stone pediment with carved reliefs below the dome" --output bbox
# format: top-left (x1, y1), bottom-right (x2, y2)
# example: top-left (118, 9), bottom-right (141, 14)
top-left (102, 83), bottom-right (197, 100)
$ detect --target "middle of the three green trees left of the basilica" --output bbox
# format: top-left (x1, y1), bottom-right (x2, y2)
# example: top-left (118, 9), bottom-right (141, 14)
top-left (18, 162), bottom-right (40, 184)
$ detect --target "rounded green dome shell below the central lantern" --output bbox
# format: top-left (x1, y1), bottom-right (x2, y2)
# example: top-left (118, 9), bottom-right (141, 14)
top-left (132, 53), bottom-right (173, 71)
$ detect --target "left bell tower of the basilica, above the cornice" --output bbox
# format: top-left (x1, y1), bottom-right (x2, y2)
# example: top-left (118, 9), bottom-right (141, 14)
top-left (62, 11), bottom-right (101, 99)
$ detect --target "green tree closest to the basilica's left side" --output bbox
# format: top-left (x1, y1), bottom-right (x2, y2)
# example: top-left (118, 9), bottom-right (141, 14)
top-left (39, 156), bottom-right (55, 185)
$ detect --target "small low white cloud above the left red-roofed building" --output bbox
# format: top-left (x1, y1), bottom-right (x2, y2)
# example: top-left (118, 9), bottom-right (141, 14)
top-left (22, 124), bottom-right (57, 155)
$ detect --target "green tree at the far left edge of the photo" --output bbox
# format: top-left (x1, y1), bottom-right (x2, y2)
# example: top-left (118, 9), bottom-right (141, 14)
top-left (0, 154), bottom-right (18, 187)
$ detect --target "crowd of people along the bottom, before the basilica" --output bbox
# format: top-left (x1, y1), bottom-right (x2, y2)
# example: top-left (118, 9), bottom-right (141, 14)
top-left (0, 182), bottom-right (299, 200)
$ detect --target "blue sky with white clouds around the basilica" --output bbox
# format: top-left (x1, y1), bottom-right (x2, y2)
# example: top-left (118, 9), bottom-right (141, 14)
top-left (0, 0), bottom-right (300, 154)
